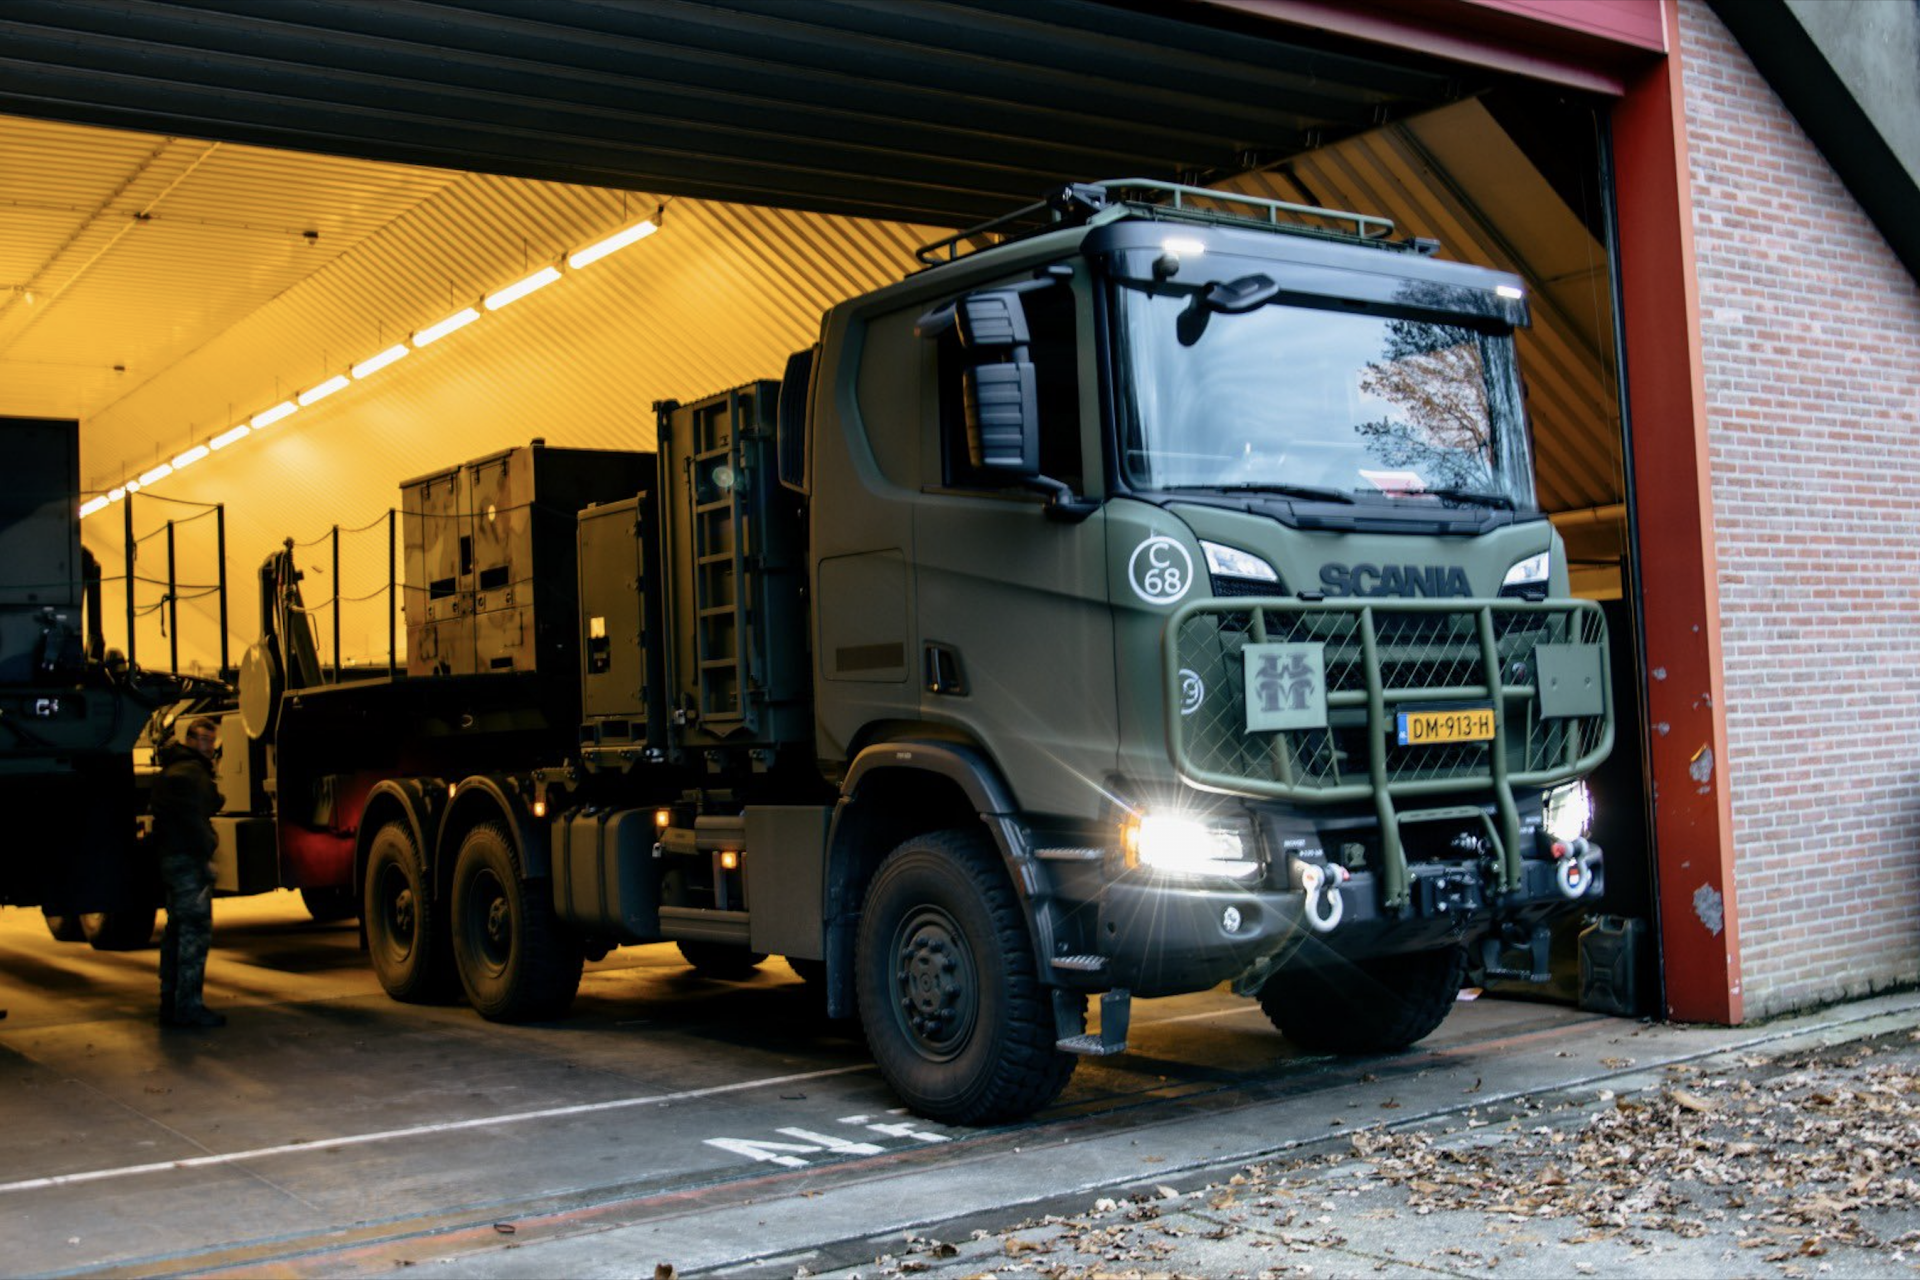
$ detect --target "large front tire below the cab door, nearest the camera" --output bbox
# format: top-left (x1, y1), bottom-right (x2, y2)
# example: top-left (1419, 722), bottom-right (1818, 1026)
top-left (854, 831), bottom-right (1075, 1125)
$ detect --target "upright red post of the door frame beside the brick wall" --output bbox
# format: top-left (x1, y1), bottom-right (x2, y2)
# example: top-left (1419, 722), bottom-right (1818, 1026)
top-left (1613, 0), bottom-right (1743, 1023)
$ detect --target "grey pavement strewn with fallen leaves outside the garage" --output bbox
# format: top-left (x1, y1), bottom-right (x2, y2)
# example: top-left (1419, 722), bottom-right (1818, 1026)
top-left (837, 1032), bottom-right (1920, 1280)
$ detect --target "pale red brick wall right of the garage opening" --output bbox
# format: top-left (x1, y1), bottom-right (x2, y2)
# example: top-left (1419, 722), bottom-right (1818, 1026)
top-left (1680, 0), bottom-right (1920, 1017)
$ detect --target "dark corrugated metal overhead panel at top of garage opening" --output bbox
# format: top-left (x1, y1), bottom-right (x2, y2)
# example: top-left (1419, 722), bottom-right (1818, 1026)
top-left (0, 0), bottom-right (1490, 225)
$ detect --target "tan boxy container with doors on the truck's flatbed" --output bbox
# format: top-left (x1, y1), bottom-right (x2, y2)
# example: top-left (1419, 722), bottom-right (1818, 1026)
top-left (401, 439), bottom-right (653, 683)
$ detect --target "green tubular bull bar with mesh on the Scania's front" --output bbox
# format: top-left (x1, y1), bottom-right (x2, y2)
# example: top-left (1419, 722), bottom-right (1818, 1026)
top-left (1164, 597), bottom-right (1613, 908)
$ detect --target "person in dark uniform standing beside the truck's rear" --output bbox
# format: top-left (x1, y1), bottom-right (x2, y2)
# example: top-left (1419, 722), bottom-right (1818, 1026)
top-left (152, 716), bottom-right (227, 1027)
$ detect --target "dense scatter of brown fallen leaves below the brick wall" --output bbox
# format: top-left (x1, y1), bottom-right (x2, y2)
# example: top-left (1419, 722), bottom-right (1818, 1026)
top-left (1354, 1032), bottom-right (1920, 1274)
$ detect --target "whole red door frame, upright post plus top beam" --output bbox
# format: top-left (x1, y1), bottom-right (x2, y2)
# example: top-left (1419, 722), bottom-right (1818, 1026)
top-left (1208, 0), bottom-right (1741, 1023)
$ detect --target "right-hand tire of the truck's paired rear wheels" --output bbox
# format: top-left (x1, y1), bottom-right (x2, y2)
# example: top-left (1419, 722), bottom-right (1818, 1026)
top-left (453, 823), bottom-right (586, 1023)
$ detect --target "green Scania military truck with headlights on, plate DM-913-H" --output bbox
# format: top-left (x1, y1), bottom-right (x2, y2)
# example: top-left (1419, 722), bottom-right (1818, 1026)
top-left (228, 180), bottom-right (1613, 1123)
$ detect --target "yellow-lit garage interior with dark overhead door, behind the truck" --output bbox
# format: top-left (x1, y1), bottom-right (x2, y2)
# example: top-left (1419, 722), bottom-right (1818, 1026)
top-left (0, 0), bottom-right (1651, 994)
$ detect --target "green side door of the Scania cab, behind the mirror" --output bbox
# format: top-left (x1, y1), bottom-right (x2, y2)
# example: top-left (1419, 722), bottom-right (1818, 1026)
top-left (914, 278), bottom-right (1116, 816)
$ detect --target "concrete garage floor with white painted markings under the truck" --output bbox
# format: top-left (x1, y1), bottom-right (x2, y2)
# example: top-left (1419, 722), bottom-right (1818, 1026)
top-left (0, 894), bottom-right (1638, 1274)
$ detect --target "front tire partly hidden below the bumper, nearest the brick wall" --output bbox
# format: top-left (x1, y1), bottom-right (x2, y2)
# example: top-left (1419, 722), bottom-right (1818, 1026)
top-left (1260, 946), bottom-right (1467, 1054)
